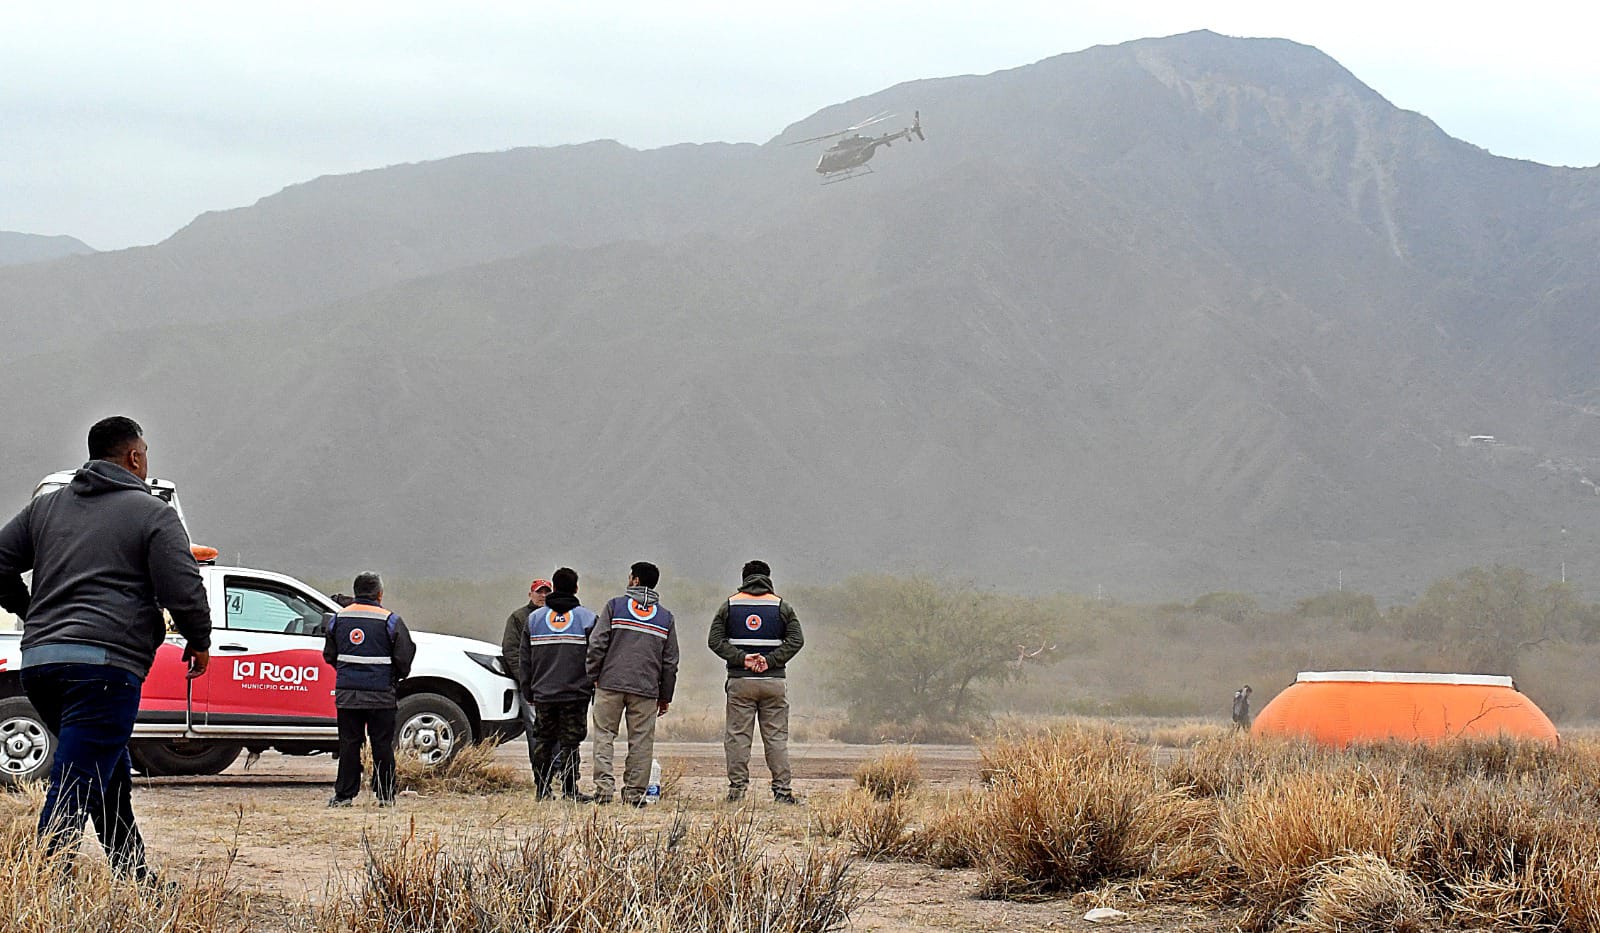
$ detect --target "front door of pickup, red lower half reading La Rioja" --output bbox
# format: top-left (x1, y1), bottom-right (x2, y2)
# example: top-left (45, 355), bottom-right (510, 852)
top-left (195, 575), bottom-right (336, 727)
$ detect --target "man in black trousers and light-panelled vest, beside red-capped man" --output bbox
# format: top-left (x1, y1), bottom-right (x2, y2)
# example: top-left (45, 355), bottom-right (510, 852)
top-left (517, 567), bottom-right (595, 803)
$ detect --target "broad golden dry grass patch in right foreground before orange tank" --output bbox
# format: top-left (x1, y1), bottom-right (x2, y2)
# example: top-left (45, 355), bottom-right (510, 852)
top-left (816, 727), bottom-right (1600, 933)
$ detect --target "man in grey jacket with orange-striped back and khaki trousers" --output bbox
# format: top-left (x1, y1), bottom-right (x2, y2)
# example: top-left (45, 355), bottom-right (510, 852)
top-left (589, 562), bottom-right (678, 807)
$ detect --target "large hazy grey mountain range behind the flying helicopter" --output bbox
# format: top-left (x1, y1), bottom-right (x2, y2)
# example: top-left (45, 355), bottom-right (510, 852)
top-left (0, 32), bottom-right (1600, 599)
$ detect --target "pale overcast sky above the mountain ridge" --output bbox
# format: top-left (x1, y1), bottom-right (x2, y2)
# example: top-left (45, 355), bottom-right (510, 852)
top-left (0, 0), bottom-right (1600, 250)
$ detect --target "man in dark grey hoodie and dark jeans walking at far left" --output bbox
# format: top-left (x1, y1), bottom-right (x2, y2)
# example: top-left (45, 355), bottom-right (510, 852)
top-left (0, 418), bottom-right (211, 880)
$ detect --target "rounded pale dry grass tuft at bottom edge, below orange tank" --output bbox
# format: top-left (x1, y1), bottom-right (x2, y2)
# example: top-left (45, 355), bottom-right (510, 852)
top-left (1285, 853), bottom-right (1438, 933)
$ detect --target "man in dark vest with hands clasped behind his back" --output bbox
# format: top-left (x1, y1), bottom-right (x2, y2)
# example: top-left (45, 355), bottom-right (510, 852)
top-left (707, 560), bottom-right (805, 803)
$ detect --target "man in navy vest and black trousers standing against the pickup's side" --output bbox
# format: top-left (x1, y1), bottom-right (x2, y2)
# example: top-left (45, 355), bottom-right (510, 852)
top-left (322, 573), bottom-right (416, 807)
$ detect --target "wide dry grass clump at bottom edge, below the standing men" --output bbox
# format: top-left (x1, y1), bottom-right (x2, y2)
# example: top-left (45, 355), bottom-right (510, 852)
top-left (315, 813), bottom-right (866, 933)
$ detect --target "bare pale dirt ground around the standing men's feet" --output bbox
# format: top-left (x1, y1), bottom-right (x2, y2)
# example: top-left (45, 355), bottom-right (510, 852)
top-left (118, 743), bottom-right (1234, 933)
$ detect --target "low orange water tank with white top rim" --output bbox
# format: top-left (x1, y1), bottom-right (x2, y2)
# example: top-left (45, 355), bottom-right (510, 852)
top-left (1250, 671), bottom-right (1560, 747)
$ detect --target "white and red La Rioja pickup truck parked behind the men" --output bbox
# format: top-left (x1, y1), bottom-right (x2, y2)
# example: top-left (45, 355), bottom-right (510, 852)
top-left (0, 474), bottom-right (522, 786)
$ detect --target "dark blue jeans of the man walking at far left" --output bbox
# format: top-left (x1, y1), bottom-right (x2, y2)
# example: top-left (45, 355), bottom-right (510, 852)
top-left (22, 664), bottom-right (147, 877)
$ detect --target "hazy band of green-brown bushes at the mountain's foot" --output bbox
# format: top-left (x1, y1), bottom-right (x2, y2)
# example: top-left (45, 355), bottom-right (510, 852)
top-left (374, 567), bottom-right (1600, 743)
